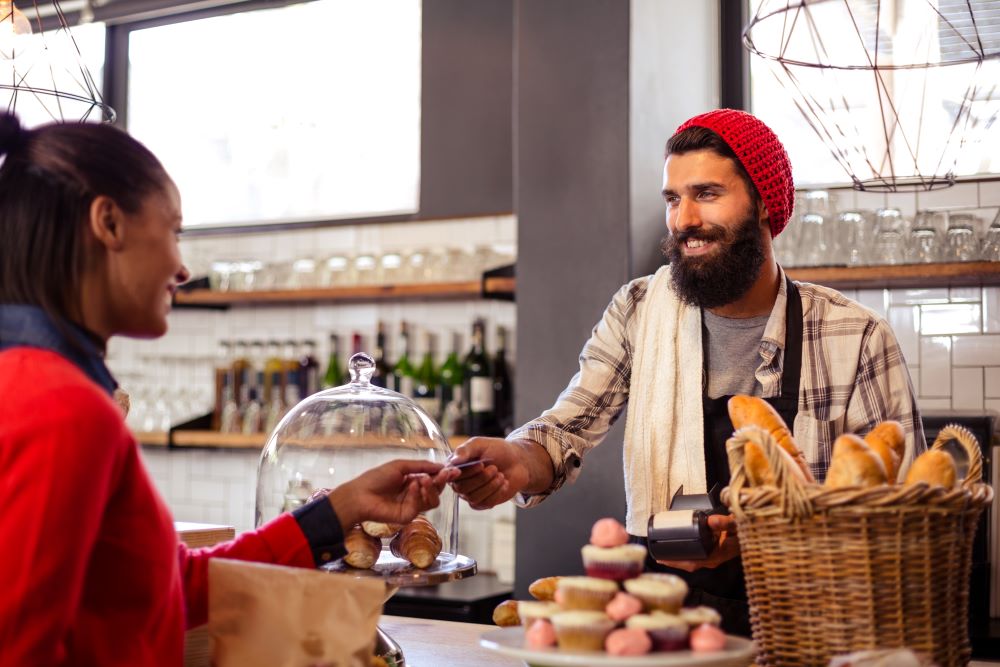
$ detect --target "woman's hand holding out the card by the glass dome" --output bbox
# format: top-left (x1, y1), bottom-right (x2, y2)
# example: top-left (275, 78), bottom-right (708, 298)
top-left (329, 459), bottom-right (459, 531)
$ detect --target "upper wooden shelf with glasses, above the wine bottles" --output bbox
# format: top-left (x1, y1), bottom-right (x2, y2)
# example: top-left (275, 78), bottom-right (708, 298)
top-left (175, 277), bottom-right (515, 307)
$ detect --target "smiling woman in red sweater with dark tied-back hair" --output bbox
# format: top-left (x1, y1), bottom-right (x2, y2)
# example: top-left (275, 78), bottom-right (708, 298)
top-left (0, 114), bottom-right (457, 666)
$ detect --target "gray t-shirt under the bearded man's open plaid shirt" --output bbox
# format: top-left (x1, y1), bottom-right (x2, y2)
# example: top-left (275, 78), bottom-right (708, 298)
top-left (701, 310), bottom-right (770, 398)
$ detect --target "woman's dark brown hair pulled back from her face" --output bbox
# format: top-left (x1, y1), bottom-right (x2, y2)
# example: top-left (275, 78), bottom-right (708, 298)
top-left (0, 113), bottom-right (168, 318)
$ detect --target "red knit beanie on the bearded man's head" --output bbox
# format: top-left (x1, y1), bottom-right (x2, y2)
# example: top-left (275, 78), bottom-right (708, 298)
top-left (674, 109), bottom-right (795, 238)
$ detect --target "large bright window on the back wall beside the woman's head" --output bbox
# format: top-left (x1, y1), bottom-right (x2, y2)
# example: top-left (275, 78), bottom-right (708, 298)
top-left (127, 0), bottom-right (421, 227)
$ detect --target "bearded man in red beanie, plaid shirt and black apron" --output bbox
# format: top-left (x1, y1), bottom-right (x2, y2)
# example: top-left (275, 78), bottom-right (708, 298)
top-left (452, 109), bottom-right (926, 635)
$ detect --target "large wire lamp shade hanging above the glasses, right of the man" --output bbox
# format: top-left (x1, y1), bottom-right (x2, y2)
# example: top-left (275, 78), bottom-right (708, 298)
top-left (743, 0), bottom-right (1000, 192)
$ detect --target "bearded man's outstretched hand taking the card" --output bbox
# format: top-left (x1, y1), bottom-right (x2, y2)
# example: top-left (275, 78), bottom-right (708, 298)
top-left (448, 438), bottom-right (552, 510)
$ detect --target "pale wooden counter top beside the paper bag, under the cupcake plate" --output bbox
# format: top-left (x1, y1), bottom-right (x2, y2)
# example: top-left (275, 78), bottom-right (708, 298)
top-left (379, 616), bottom-right (1000, 667)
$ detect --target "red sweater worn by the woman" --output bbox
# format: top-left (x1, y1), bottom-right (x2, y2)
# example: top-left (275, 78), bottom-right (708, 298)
top-left (0, 347), bottom-right (315, 667)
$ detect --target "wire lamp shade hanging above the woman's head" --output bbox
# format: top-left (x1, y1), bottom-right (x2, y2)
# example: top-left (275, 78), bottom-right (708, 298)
top-left (0, 0), bottom-right (115, 126)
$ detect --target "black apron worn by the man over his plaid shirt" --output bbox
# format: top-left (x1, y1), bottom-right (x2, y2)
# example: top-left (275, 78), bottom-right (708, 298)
top-left (634, 278), bottom-right (802, 637)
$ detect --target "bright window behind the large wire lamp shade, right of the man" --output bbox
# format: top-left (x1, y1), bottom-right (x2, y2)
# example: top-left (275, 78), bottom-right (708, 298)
top-left (750, 0), bottom-right (1000, 189)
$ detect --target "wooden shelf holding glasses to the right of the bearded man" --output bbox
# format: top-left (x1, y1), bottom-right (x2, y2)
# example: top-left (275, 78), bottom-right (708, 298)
top-left (786, 262), bottom-right (1000, 289)
